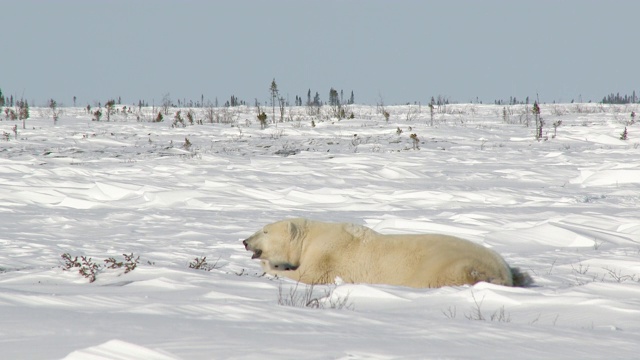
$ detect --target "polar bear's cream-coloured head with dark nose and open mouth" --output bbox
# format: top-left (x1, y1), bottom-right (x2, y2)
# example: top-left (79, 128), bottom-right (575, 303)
top-left (242, 219), bottom-right (304, 270)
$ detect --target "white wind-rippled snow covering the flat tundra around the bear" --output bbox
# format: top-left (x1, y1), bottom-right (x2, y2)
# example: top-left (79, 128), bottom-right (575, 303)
top-left (0, 104), bottom-right (640, 359)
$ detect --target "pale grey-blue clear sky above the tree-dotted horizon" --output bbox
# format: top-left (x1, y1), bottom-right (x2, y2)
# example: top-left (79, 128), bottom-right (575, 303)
top-left (0, 0), bottom-right (640, 106)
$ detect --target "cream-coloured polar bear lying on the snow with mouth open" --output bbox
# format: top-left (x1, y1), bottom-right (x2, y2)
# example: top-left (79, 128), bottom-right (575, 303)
top-left (243, 218), bottom-right (531, 288)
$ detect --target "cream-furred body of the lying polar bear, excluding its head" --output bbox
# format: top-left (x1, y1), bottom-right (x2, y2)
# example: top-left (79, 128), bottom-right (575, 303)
top-left (300, 222), bottom-right (513, 287)
